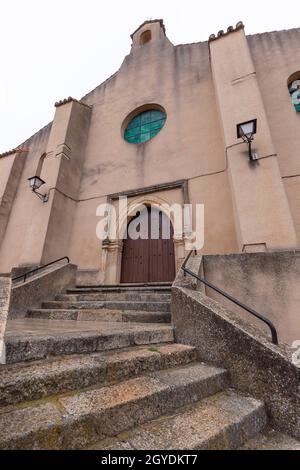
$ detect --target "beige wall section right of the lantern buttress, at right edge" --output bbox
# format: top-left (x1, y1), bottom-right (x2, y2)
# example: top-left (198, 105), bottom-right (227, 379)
top-left (248, 28), bottom-right (300, 244)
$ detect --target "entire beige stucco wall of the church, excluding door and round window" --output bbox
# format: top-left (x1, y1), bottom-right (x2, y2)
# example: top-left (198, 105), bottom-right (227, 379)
top-left (0, 22), bottom-right (300, 282)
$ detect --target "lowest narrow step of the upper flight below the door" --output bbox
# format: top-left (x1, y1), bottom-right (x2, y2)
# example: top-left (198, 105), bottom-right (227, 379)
top-left (26, 308), bottom-right (171, 323)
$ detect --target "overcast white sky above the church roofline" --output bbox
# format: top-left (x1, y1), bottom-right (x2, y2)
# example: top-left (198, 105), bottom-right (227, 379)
top-left (0, 0), bottom-right (300, 152)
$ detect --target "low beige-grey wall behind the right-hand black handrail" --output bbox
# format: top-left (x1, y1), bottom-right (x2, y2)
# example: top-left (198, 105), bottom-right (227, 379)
top-left (203, 250), bottom-right (300, 344)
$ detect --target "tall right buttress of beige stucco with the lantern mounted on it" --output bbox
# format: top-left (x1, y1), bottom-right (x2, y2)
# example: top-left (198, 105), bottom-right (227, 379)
top-left (209, 24), bottom-right (297, 251)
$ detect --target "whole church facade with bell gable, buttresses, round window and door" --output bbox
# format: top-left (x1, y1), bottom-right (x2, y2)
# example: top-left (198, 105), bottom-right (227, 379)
top-left (0, 20), bottom-right (300, 284)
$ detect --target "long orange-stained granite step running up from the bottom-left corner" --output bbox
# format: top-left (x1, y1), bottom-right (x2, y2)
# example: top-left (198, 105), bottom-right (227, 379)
top-left (0, 363), bottom-right (227, 450)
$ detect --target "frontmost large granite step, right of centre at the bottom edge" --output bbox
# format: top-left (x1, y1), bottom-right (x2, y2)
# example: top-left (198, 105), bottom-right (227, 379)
top-left (92, 390), bottom-right (267, 451)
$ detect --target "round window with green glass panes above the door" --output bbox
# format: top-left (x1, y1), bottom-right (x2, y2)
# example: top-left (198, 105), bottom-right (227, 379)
top-left (124, 109), bottom-right (167, 144)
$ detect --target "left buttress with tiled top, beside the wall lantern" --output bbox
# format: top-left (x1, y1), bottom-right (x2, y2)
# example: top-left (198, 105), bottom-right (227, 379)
top-left (20, 98), bottom-right (91, 264)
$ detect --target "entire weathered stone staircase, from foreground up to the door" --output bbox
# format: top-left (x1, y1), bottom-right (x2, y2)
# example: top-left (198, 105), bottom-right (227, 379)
top-left (0, 286), bottom-right (299, 450)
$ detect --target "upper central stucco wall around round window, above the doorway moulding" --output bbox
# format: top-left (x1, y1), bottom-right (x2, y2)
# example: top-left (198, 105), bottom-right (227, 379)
top-left (80, 40), bottom-right (224, 199)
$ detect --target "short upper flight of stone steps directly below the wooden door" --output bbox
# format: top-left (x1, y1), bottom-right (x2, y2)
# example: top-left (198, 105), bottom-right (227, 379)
top-left (27, 284), bottom-right (171, 323)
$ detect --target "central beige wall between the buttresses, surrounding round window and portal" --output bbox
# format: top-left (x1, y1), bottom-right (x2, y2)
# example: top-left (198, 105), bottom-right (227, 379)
top-left (71, 26), bottom-right (237, 276)
